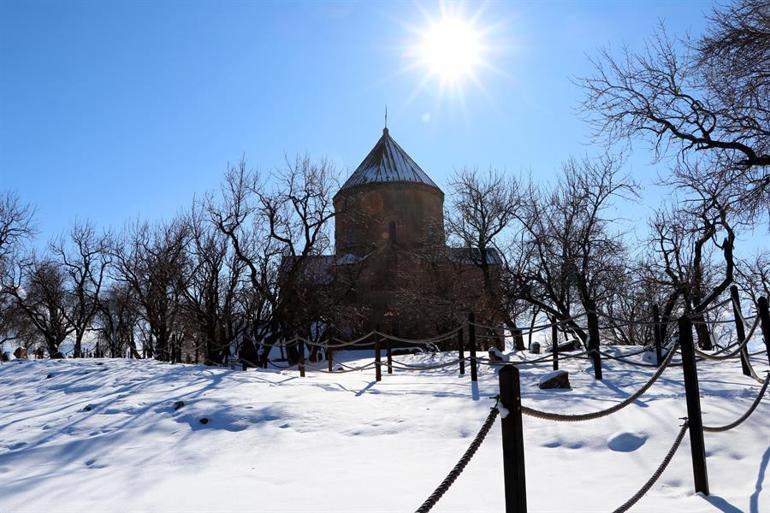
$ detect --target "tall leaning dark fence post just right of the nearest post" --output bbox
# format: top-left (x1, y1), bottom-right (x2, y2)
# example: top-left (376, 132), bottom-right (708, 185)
top-left (679, 315), bottom-right (709, 495)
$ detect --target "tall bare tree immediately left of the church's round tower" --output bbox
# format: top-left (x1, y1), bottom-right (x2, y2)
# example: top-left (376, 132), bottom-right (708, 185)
top-left (209, 158), bottom-right (335, 365)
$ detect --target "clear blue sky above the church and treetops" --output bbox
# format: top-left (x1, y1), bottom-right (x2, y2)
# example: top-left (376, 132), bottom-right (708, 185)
top-left (0, 0), bottom-right (736, 248)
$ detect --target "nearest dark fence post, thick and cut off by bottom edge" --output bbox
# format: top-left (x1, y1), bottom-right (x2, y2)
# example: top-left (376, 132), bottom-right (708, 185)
top-left (500, 365), bottom-right (527, 513)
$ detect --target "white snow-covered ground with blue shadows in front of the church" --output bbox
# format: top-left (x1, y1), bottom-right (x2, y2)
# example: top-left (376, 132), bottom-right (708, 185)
top-left (0, 346), bottom-right (770, 513)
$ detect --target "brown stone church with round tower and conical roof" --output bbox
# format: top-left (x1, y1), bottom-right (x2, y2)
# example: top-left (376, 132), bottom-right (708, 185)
top-left (286, 128), bottom-right (501, 339)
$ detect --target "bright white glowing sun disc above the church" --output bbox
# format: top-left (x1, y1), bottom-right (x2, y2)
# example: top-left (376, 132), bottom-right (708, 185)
top-left (417, 17), bottom-right (483, 85)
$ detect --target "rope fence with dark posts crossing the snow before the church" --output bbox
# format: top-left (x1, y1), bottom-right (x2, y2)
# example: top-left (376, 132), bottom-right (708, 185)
top-left (195, 292), bottom-right (770, 513)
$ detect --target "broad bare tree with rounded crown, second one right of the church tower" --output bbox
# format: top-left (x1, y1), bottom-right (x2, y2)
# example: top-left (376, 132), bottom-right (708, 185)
top-left (507, 156), bottom-right (637, 340)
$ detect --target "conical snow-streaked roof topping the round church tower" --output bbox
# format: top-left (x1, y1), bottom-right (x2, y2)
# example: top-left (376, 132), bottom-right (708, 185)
top-left (340, 128), bottom-right (440, 191)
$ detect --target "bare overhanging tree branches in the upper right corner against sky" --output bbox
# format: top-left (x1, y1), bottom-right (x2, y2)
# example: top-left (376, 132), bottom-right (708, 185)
top-left (580, 0), bottom-right (770, 218)
